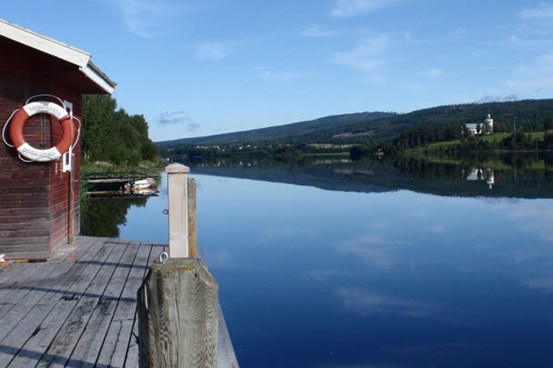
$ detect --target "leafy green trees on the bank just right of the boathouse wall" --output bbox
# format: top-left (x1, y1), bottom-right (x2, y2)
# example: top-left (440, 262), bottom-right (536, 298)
top-left (82, 95), bottom-right (159, 165)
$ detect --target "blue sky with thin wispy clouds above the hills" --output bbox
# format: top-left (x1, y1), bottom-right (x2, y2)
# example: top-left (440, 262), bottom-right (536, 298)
top-left (0, 0), bottom-right (553, 141)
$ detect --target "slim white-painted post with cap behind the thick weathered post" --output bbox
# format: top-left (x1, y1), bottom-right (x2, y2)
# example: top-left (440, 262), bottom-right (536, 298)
top-left (165, 164), bottom-right (190, 258)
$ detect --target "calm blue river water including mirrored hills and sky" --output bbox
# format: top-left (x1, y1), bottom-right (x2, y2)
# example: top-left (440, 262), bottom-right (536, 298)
top-left (84, 156), bottom-right (553, 368)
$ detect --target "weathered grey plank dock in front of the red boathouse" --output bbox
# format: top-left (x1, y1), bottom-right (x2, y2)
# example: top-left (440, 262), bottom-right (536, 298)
top-left (0, 237), bottom-right (238, 368)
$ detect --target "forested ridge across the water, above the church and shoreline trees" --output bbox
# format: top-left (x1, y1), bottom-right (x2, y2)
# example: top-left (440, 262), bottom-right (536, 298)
top-left (157, 99), bottom-right (553, 148)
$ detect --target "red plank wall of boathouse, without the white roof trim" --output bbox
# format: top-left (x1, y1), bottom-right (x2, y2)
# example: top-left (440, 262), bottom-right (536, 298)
top-left (0, 37), bottom-right (81, 259)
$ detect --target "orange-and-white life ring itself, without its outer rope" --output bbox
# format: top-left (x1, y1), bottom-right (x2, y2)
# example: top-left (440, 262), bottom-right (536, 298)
top-left (10, 101), bottom-right (75, 162)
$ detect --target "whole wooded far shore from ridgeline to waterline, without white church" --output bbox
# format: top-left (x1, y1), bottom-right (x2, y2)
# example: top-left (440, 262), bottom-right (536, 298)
top-left (158, 99), bottom-right (553, 157)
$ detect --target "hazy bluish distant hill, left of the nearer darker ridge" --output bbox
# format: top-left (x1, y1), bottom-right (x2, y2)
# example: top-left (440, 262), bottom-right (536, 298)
top-left (156, 112), bottom-right (395, 147)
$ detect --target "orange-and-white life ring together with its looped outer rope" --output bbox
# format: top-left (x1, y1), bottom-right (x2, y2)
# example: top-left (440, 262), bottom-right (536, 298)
top-left (2, 94), bottom-right (81, 162)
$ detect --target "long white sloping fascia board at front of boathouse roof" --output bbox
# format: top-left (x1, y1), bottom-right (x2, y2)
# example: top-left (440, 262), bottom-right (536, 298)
top-left (0, 18), bottom-right (91, 67)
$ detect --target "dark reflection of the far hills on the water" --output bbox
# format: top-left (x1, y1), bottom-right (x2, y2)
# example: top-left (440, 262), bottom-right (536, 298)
top-left (182, 153), bottom-right (553, 198)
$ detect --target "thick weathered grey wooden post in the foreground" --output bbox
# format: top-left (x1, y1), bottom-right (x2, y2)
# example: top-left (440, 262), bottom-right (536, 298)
top-left (138, 258), bottom-right (219, 368)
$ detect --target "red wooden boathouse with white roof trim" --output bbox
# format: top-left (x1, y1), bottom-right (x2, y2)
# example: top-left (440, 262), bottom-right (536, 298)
top-left (0, 19), bottom-right (115, 259)
